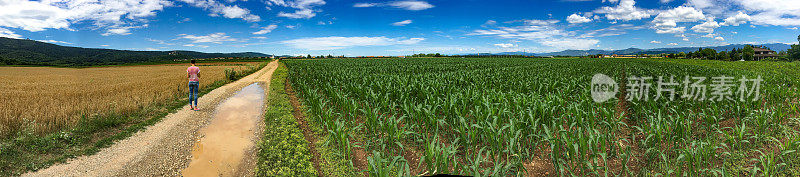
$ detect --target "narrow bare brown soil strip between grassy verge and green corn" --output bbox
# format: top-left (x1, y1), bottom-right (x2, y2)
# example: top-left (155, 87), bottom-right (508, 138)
top-left (285, 79), bottom-right (324, 176)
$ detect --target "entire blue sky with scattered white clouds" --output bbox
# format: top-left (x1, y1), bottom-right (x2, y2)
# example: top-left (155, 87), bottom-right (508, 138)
top-left (0, 0), bottom-right (800, 56)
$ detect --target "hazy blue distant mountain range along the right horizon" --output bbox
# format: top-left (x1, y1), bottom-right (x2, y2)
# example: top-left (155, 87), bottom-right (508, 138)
top-left (480, 43), bottom-right (791, 56)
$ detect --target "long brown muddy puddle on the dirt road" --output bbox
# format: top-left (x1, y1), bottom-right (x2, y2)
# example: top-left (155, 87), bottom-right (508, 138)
top-left (182, 84), bottom-right (264, 176)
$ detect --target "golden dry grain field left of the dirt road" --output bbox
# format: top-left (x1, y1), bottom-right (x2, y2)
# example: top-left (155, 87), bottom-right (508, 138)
top-left (0, 62), bottom-right (258, 136)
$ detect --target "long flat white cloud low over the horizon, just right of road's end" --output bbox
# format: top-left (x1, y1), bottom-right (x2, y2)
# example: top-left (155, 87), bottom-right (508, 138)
top-left (281, 36), bottom-right (425, 50)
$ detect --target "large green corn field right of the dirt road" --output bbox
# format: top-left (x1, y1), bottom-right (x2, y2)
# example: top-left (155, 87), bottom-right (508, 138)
top-left (285, 58), bottom-right (800, 176)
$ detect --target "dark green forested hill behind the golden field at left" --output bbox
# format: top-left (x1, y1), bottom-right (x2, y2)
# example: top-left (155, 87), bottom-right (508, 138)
top-left (0, 37), bottom-right (270, 66)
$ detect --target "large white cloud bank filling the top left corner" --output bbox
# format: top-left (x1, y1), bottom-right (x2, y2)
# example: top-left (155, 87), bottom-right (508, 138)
top-left (0, 0), bottom-right (172, 32)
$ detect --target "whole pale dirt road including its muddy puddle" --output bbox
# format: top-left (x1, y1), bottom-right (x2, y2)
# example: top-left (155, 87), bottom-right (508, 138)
top-left (22, 60), bottom-right (278, 176)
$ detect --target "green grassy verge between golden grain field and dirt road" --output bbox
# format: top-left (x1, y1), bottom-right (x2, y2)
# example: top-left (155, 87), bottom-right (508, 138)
top-left (0, 63), bottom-right (266, 176)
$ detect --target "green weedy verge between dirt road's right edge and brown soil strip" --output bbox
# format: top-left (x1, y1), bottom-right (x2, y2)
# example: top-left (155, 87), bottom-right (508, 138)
top-left (256, 64), bottom-right (317, 176)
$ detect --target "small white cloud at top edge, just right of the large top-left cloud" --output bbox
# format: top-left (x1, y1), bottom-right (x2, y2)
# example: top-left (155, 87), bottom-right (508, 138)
top-left (180, 0), bottom-right (261, 22)
